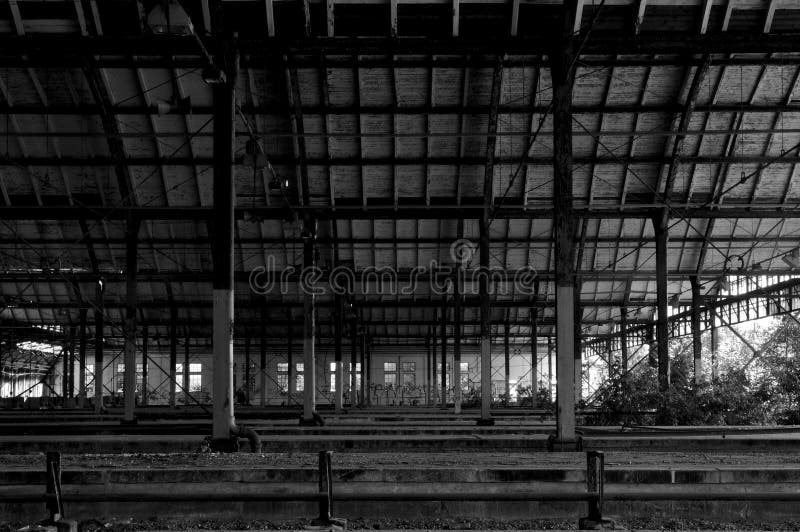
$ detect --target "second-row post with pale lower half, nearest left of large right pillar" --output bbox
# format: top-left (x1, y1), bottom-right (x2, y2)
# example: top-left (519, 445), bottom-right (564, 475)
top-left (478, 216), bottom-right (494, 425)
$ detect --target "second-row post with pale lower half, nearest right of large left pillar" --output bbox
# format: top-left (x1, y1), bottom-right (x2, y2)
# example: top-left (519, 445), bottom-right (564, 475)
top-left (302, 219), bottom-right (317, 424)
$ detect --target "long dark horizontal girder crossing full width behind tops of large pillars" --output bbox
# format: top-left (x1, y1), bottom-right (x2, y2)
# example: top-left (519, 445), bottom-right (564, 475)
top-left (0, 30), bottom-right (800, 61)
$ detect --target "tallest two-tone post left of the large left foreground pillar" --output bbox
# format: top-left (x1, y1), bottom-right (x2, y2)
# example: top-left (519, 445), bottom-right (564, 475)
top-left (122, 218), bottom-right (139, 424)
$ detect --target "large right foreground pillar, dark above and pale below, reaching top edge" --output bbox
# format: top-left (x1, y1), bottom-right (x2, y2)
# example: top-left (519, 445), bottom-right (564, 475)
top-left (550, 0), bottom-right (580, 450)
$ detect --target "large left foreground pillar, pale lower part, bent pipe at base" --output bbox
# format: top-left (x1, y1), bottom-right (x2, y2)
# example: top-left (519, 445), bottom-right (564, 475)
top-left (212, 42), bottom-right (239, 445)
